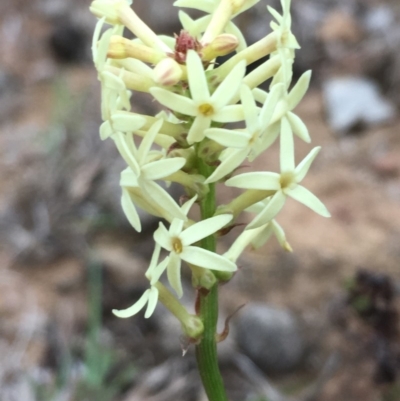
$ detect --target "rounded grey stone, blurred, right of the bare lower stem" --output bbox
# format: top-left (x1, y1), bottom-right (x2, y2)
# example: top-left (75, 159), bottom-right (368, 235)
top-left (236, 303), bottom-right (305, 373)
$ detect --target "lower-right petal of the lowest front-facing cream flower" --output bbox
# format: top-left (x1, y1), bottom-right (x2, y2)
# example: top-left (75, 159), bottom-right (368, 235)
top-left (180, 246), bottom-right (237, 272)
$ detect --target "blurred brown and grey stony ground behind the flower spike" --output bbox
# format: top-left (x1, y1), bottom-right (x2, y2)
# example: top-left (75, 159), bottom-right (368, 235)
top-left (0, 0), bottom-right (400, 401)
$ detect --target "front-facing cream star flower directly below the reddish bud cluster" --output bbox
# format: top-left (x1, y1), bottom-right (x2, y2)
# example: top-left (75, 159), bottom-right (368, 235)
top-left (150, 50), bottom-right (246, 144)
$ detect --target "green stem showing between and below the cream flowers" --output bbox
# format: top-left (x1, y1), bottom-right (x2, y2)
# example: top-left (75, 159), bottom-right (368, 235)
top-left (196, 158), bottom-right (228, 401)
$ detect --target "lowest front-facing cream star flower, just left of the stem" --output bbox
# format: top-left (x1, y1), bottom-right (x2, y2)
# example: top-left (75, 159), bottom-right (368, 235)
top-left (154, 199), bottom-right (236, 297)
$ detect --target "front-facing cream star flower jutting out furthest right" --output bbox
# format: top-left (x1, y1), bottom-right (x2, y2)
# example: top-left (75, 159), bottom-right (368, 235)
top-left (226, 118), bottom-right (330, 229)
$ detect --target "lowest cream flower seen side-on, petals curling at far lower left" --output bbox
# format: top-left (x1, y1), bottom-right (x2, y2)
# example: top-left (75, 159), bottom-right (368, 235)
top-left (112, 244), bottom-right (169, 319)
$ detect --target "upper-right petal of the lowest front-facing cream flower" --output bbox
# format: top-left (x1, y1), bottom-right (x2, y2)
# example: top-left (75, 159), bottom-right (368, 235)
top-left (180, 214), bottom-right (233, 246)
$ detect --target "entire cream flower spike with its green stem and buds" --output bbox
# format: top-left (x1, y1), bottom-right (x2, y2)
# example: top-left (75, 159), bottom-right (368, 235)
top-left (90, 0), bottom-right (329, 401)
